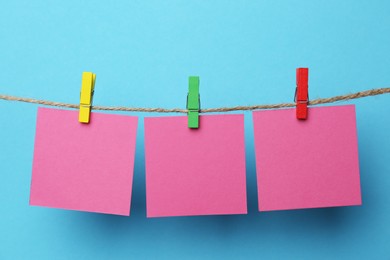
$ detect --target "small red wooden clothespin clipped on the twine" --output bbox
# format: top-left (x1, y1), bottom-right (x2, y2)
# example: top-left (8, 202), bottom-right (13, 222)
top-left (295, 68), bottom-right (309, 120)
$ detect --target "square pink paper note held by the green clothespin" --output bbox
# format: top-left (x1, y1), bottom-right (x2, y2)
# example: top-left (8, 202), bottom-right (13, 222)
top-left (145, 115), bottom-right (247, 217)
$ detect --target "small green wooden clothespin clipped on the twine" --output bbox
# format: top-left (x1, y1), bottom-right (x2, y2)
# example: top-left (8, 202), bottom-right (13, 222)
top-left (187, 76), bottom-right (200, 128)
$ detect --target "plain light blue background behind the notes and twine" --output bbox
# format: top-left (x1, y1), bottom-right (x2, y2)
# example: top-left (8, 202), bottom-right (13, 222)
top-left (0, 0), bottom-right (390, 259)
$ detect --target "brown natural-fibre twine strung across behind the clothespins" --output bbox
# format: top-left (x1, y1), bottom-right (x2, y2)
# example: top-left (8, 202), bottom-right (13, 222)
top-left (0, 88), bottom-right (390, 113)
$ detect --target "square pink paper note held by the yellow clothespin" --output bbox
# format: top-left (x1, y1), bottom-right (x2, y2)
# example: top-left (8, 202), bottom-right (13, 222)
top-left (30, 108), bottom-right (138, 216)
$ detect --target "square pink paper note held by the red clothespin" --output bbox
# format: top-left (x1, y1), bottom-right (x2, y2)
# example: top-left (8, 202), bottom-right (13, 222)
top-left (253, 105), bottom-right (361, 211)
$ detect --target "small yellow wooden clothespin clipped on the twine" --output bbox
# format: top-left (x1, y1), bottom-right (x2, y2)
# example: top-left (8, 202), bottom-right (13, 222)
top-left (79, 72), bottom-right (96, 124)
